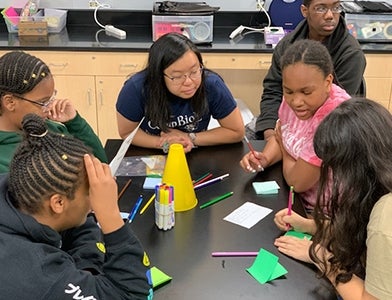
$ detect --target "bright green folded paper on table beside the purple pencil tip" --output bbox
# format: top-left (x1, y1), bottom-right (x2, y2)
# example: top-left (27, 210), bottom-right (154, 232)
top-left (246, 248), bottom-right (287, 284)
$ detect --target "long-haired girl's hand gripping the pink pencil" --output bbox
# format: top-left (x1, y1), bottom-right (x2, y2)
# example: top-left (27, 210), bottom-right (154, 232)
top-left (274, 208), bottom-right (316, 234)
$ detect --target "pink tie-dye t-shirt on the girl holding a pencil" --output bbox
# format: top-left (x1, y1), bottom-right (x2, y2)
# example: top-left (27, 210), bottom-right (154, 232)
top-left (279, 84), bottom-right (351, 210)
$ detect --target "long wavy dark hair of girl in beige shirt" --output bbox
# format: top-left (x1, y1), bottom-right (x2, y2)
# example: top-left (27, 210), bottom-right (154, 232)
top-left (310, 99), bottom-right (392, 284)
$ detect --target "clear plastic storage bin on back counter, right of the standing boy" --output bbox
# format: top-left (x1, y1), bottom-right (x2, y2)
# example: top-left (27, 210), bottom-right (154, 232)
top-left (345, 13), bottom-right (392, 43)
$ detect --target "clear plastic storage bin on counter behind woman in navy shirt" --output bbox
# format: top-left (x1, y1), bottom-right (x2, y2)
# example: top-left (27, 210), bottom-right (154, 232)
top-left (152, 14), bottom-right (214, 44)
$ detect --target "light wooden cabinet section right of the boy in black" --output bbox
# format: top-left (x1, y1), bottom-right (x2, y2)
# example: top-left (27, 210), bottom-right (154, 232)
top-left (365, 54), bottom-right (392, 112)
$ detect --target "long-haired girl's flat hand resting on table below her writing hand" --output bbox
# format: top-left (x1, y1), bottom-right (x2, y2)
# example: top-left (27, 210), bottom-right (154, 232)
top-left (274, 236), bottom-right (313, 263)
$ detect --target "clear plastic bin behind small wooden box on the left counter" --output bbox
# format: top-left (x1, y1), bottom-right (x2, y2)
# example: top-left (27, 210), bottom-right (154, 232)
top-left (4, 8), bottom-right (67, 33)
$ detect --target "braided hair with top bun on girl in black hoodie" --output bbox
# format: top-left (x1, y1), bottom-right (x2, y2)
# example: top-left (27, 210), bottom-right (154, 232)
top-left (9, 114), bottom-right (91, 214)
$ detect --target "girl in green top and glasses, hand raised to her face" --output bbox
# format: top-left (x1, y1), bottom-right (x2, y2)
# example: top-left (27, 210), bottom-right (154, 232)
top-left (0, 51), bottom-right (107, 173)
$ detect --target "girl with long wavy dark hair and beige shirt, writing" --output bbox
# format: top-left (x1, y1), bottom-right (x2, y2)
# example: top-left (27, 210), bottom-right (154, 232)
top-left (275, 99), bottom-right (392, 300)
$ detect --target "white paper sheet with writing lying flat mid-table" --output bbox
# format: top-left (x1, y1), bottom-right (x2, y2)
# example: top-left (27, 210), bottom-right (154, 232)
top-left (223, 202), bottom-right (272, 229)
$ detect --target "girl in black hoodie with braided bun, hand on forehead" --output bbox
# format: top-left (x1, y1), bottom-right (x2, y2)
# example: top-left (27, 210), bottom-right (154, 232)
top-left (0, 114), bottom-right (152, 299)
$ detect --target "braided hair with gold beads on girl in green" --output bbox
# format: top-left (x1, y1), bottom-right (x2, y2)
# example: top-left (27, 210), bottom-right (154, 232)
top-left (0, 51), bottom-right (51, 114)
